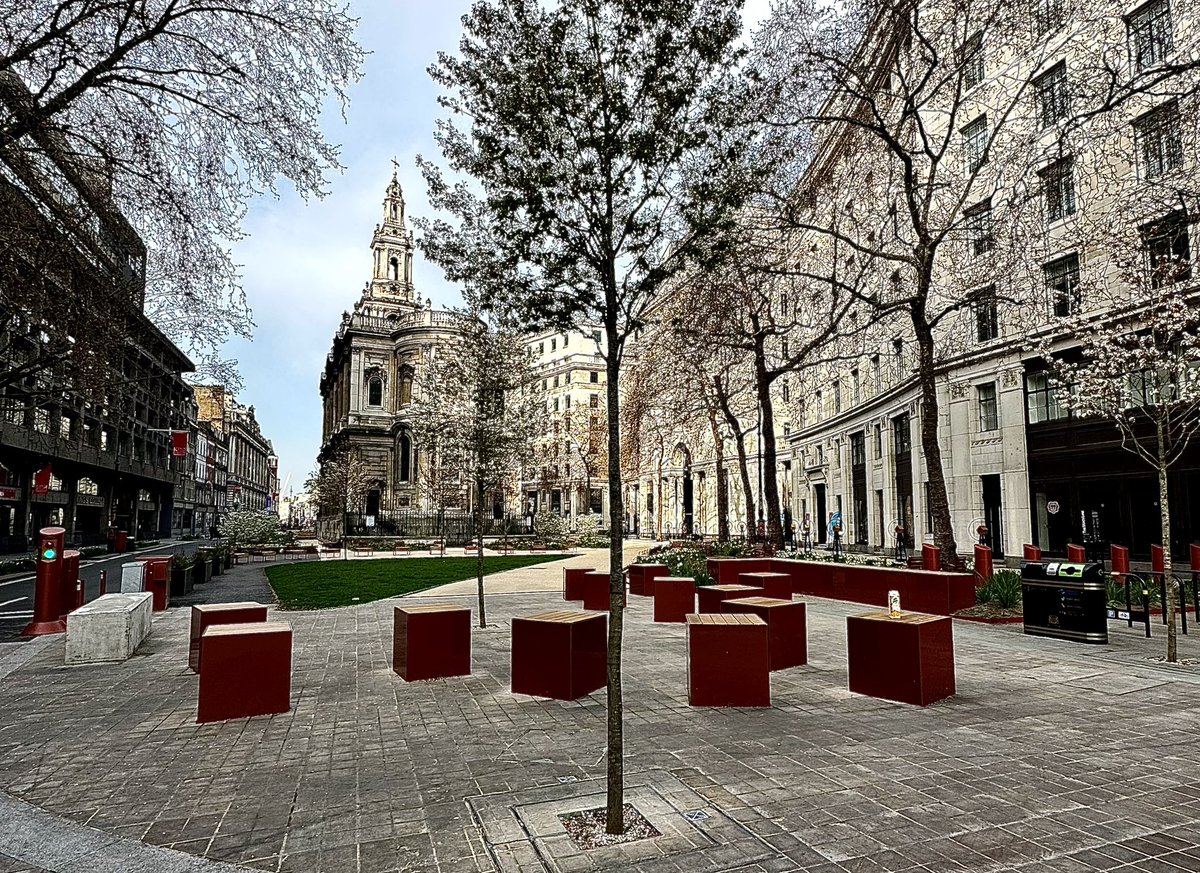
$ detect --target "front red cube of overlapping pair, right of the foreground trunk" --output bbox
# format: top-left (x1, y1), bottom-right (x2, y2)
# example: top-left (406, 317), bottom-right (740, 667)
top-left (688, 614), bottom-right (770, 706)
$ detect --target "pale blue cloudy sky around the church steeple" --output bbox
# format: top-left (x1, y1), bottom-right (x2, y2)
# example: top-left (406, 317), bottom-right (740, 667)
top-left (226, 0), bottom-right (770, 496)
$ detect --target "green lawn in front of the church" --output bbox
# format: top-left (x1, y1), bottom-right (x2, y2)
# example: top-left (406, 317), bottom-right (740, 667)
top-left (266, 555), bottom-right (563, 609)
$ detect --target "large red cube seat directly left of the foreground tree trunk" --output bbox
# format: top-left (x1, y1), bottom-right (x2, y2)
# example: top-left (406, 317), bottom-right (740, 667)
top-left (512, 609), bottom-right (608, 700)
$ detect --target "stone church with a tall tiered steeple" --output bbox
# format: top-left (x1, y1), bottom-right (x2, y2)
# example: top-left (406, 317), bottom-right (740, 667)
top-left (318, 173), bottom-right (455, 517)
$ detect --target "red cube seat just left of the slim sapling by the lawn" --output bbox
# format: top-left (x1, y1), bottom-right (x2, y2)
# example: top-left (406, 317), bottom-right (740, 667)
top-left (391, 603), bottom-right (470, 682)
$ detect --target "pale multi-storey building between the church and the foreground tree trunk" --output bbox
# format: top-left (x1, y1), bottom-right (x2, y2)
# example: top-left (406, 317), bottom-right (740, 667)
top-left (522, 327), bottom-right (608, 517)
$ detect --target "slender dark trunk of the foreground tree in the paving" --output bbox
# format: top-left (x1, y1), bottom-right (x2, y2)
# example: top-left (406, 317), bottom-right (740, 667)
top-left (605, 316), bottom-right (625, 833)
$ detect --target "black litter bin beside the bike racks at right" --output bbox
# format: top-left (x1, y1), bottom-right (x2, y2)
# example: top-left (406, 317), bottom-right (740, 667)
top-left (1021, 561), bottom-right (1109, 643)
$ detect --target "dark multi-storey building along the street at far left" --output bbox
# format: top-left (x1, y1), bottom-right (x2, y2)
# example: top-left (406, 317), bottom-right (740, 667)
top-left (0, 90), bottom-right (193, 552)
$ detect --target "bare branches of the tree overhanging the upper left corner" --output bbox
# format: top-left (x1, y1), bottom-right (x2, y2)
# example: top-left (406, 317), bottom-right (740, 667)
top-left (0, 0), bottom-right (364, 377)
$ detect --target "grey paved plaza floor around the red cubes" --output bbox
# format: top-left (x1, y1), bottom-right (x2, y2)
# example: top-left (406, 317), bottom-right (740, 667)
top-left (0, 553), bottom-right (1200, 873)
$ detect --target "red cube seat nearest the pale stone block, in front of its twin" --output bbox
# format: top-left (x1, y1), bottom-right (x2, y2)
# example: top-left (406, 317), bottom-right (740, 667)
top-left (196, 621), bottom-right (292, 723)
